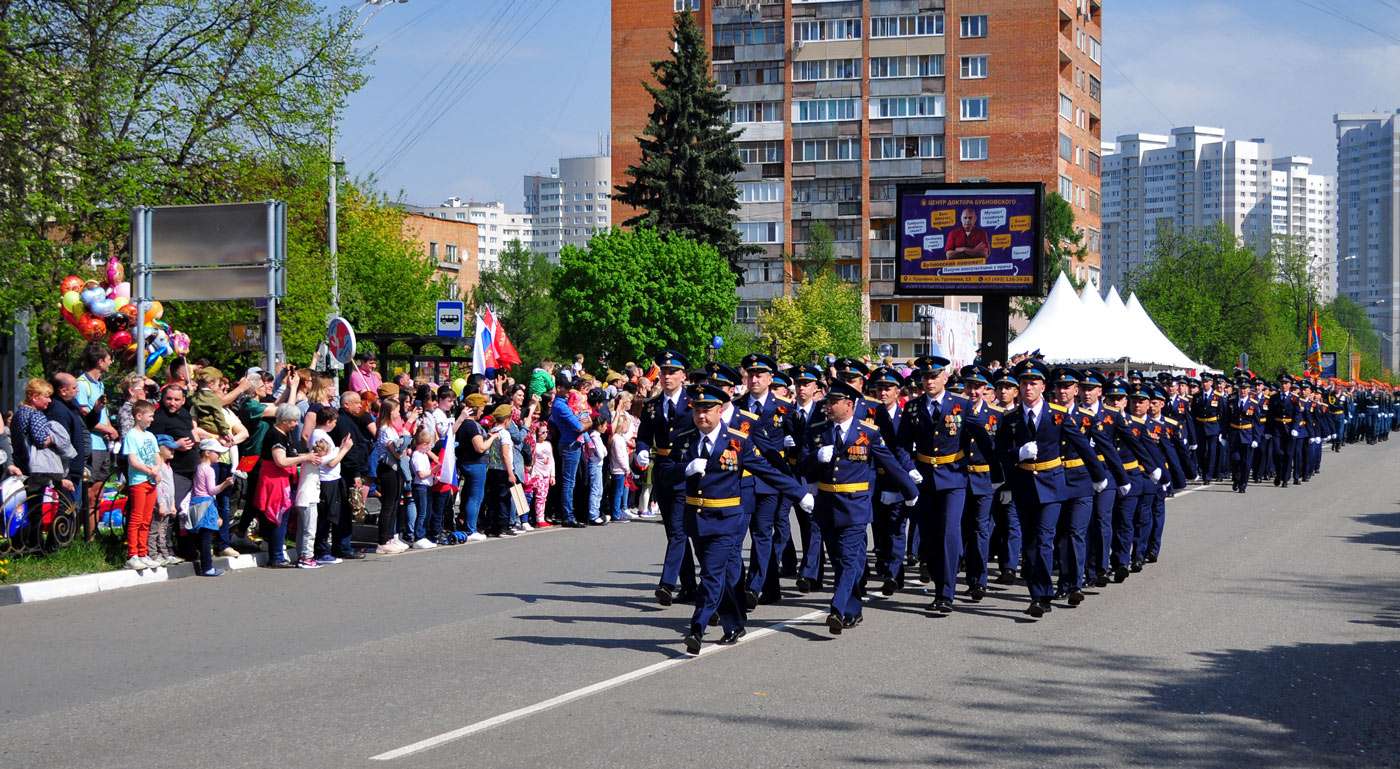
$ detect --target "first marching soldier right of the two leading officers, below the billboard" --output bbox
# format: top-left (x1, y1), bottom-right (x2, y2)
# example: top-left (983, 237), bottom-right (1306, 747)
top-left (899, 356), bottom-right (1001, 614)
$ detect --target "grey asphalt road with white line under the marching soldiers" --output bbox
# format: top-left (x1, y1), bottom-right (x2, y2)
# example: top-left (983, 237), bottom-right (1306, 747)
top-left (0, 443), bottom-right (1400, 769)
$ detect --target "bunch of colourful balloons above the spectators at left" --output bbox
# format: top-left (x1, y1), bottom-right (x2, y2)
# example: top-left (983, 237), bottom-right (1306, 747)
top-left (59, 256), bottom-right (189, 374)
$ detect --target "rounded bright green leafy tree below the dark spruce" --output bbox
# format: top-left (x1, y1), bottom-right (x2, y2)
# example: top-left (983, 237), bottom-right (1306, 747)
top-left (553, 228), bottom-right (738, 360)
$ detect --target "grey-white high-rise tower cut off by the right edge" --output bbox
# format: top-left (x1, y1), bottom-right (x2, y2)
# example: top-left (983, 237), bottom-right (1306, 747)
top-left (1333, 111), bottom-right (1400, 370)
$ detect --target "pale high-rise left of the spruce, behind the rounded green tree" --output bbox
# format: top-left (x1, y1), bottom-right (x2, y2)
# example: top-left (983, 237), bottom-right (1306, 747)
top-left (525, 154), bottom-right (612, 262)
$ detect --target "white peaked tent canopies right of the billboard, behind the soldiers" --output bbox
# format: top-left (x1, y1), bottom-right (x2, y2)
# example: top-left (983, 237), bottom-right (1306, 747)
top-left (1008, 273), bottom-right (1204, 368)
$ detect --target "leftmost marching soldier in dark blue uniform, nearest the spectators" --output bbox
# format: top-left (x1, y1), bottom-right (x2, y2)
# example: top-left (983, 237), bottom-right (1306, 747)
top-left (634, 350), bottom-right (696, 607)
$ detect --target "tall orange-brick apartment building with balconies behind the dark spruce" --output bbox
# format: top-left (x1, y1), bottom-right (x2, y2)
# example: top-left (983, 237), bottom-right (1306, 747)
top-left (612, 0), bottom-right (1103, 357)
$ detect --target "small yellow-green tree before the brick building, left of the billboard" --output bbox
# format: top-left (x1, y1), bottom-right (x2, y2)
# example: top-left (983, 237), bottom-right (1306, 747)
top-left (759, 270), bottom-right (869, 363)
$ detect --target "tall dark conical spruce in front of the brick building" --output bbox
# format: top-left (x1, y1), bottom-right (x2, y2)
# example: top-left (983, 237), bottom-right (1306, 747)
top-left (613, 13), bottom-right (760, 272)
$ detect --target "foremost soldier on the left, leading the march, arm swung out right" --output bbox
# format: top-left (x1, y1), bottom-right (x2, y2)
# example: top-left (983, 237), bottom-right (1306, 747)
top-left (675, 385), bottom-right (813, 654)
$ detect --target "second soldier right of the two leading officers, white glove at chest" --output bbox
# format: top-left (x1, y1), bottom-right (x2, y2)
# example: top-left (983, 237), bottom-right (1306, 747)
top-left (995, 359), bottom-right (1102, 618)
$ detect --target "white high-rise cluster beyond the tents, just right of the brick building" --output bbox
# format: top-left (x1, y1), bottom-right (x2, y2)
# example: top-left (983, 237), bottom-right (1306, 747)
top-left (1103, 126), bottom-right (1331, 296)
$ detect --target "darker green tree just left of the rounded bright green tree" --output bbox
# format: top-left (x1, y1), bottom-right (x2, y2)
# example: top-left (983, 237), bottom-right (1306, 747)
top-left (472, 240), bottom-right (559, 367)
